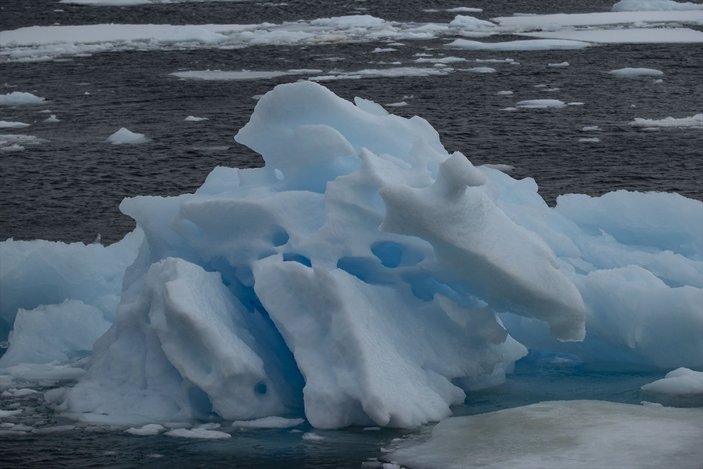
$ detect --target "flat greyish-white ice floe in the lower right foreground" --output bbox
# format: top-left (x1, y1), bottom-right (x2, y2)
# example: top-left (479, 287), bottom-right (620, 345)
top-left (388, 401), bottom-right (703, 469)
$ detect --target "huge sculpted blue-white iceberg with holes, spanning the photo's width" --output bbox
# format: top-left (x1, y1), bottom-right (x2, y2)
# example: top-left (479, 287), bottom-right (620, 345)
top-left (0, 82), bottom-right (703, 428)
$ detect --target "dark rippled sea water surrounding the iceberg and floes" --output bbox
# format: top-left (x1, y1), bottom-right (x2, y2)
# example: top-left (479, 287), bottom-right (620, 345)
top-left (0, 0), bottom-right (703, 468)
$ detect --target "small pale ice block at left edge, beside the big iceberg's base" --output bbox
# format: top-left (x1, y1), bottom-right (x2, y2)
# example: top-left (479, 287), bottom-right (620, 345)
top-left (0, 300), bottom-right (110, 368)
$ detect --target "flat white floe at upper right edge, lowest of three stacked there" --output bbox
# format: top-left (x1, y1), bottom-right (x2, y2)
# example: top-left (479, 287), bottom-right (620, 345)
top-left (520, 28), bottom-right (703, 44)
